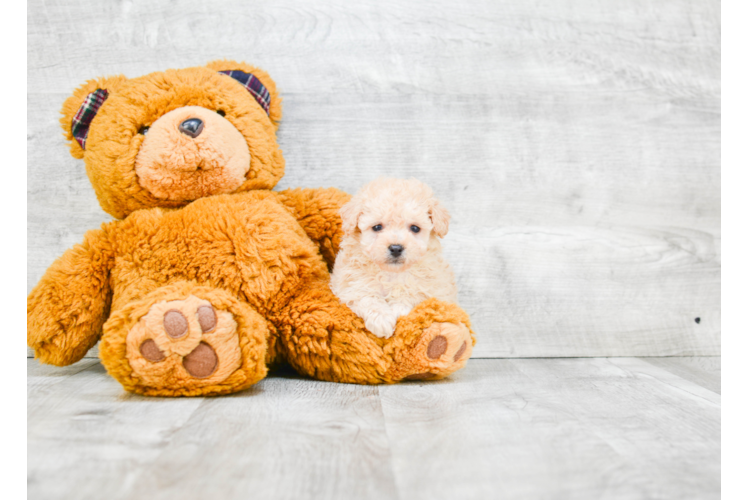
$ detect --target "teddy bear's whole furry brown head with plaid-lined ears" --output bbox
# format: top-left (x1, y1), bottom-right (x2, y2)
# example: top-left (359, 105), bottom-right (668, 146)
top-left (61, 60), bottom-right (284, 219)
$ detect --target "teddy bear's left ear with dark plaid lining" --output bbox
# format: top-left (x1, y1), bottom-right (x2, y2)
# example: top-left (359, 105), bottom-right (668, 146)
top-left (60, 76), bottom-right (127, 158)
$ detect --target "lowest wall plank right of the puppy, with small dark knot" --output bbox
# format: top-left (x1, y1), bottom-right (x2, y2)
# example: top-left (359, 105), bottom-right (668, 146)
top-left (445, 227), bottom-right (721, 357)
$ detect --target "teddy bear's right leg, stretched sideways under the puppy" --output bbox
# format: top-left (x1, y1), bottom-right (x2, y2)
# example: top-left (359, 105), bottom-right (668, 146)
top-left (277, 282), bottom-right (474, 384)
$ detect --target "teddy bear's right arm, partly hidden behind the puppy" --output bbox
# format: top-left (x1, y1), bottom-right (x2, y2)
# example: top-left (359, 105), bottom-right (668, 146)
top-left (278, 188), bottom-right (351, 269)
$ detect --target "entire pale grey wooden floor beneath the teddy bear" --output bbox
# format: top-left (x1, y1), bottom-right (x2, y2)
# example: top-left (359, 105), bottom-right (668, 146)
top-left (26, 357), bottom-right (720, 500)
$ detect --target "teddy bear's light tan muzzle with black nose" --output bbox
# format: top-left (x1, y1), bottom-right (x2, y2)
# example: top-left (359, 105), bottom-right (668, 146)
top-left (135, 106), bottom-right (251, 201)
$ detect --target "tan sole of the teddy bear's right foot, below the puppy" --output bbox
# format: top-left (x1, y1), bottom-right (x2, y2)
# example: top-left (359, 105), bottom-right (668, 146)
top-left (400, 323), bottom-right (473, 380)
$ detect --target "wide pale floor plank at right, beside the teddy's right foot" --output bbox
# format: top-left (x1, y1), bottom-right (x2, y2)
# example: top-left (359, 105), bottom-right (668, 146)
top-left (381, 359), bottom-right (720, 499)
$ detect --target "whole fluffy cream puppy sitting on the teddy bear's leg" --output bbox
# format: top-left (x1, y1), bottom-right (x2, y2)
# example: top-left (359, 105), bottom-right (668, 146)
top-left (330, 179), bottom-right (457, 338)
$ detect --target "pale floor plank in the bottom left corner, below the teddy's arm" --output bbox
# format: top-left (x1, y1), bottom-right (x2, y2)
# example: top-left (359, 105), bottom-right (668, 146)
top-left (26, 360), bottom-right (202, 499)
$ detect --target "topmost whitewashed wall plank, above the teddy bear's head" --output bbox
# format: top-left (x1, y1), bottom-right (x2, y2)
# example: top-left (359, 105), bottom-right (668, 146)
top-left (27, 0), bottom-right (717, 98)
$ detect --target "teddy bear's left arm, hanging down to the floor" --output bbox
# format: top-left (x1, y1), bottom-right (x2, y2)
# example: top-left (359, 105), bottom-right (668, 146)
top-left (26, 230), bottom-right (114, 366)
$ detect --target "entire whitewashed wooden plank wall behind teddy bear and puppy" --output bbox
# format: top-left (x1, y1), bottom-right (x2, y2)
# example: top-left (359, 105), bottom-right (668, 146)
top-left (26, 0), bottom-right (720, 357)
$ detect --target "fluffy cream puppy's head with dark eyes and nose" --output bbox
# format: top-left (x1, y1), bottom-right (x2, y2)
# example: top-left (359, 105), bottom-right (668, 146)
top-left (340, 179), bottom-right (449, 272)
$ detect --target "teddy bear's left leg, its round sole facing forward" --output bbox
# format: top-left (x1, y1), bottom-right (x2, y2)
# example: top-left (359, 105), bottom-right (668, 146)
top-left (99, 283), bottom-right (268, 396)
